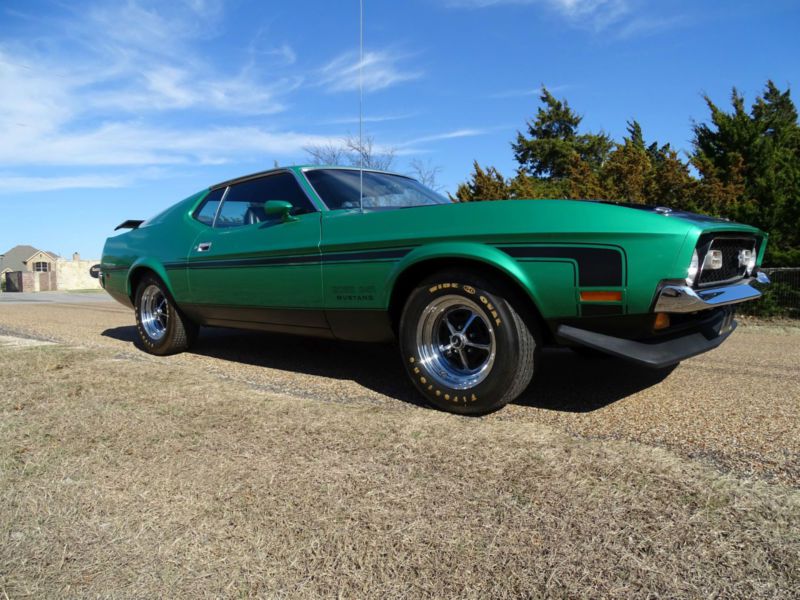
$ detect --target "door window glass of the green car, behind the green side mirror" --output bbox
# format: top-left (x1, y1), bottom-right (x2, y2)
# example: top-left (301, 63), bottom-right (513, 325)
top-left (215, 173), bottom-right (315, 227)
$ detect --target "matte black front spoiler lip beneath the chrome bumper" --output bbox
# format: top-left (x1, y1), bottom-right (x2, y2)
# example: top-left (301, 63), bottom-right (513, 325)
top-left (556, 308), bottom-right (736, 369)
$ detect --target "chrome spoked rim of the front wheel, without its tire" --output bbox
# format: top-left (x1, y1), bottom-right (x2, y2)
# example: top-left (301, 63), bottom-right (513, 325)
top-left (416, 295), bottom-right (497, 390)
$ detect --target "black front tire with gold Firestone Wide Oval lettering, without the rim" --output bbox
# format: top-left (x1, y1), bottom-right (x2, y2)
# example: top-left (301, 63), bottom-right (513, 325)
top-left (399, 277), bottom-right (519, 414)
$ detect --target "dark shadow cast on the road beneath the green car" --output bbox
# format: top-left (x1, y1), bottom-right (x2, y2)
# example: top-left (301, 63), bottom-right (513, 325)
top-left (103, 326), bottom-right (674, 413)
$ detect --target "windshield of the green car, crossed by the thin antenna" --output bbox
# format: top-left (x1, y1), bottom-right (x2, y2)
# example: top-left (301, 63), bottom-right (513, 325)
top-left (305, 169), bottom-right (449, 210)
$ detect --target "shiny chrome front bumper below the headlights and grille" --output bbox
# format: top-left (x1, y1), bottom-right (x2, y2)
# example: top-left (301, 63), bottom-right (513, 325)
top-left (653, 271), bottom-right (769, 313)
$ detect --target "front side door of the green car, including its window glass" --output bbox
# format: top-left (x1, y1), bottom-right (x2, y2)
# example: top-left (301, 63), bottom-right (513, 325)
top-left (187, 171), bottom-right (327, 329)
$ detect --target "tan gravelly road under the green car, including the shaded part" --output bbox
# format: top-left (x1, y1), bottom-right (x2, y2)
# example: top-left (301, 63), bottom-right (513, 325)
top-left (0, 294), bottom-right (800, 485)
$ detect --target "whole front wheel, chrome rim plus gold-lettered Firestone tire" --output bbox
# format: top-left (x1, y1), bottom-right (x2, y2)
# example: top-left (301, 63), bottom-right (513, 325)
top-left (399, 271), bottom-right (538, 414)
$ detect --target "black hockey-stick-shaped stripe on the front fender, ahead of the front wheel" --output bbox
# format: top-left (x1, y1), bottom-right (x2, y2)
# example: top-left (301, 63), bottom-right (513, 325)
top-left (500, 246), bottom-right (623, 287)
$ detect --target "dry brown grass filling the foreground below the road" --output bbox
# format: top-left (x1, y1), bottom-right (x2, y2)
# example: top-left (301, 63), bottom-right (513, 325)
top-left (0, 346), bottom-right (800, 598)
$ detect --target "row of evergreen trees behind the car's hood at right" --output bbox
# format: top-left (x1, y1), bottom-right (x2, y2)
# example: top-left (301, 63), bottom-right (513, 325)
top-left (453, 81), bottom-right (800, 266)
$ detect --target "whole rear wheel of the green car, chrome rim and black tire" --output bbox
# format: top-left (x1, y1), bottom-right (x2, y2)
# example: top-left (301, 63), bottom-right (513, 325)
top-left (134, 275), bottom-right (198, 356)
